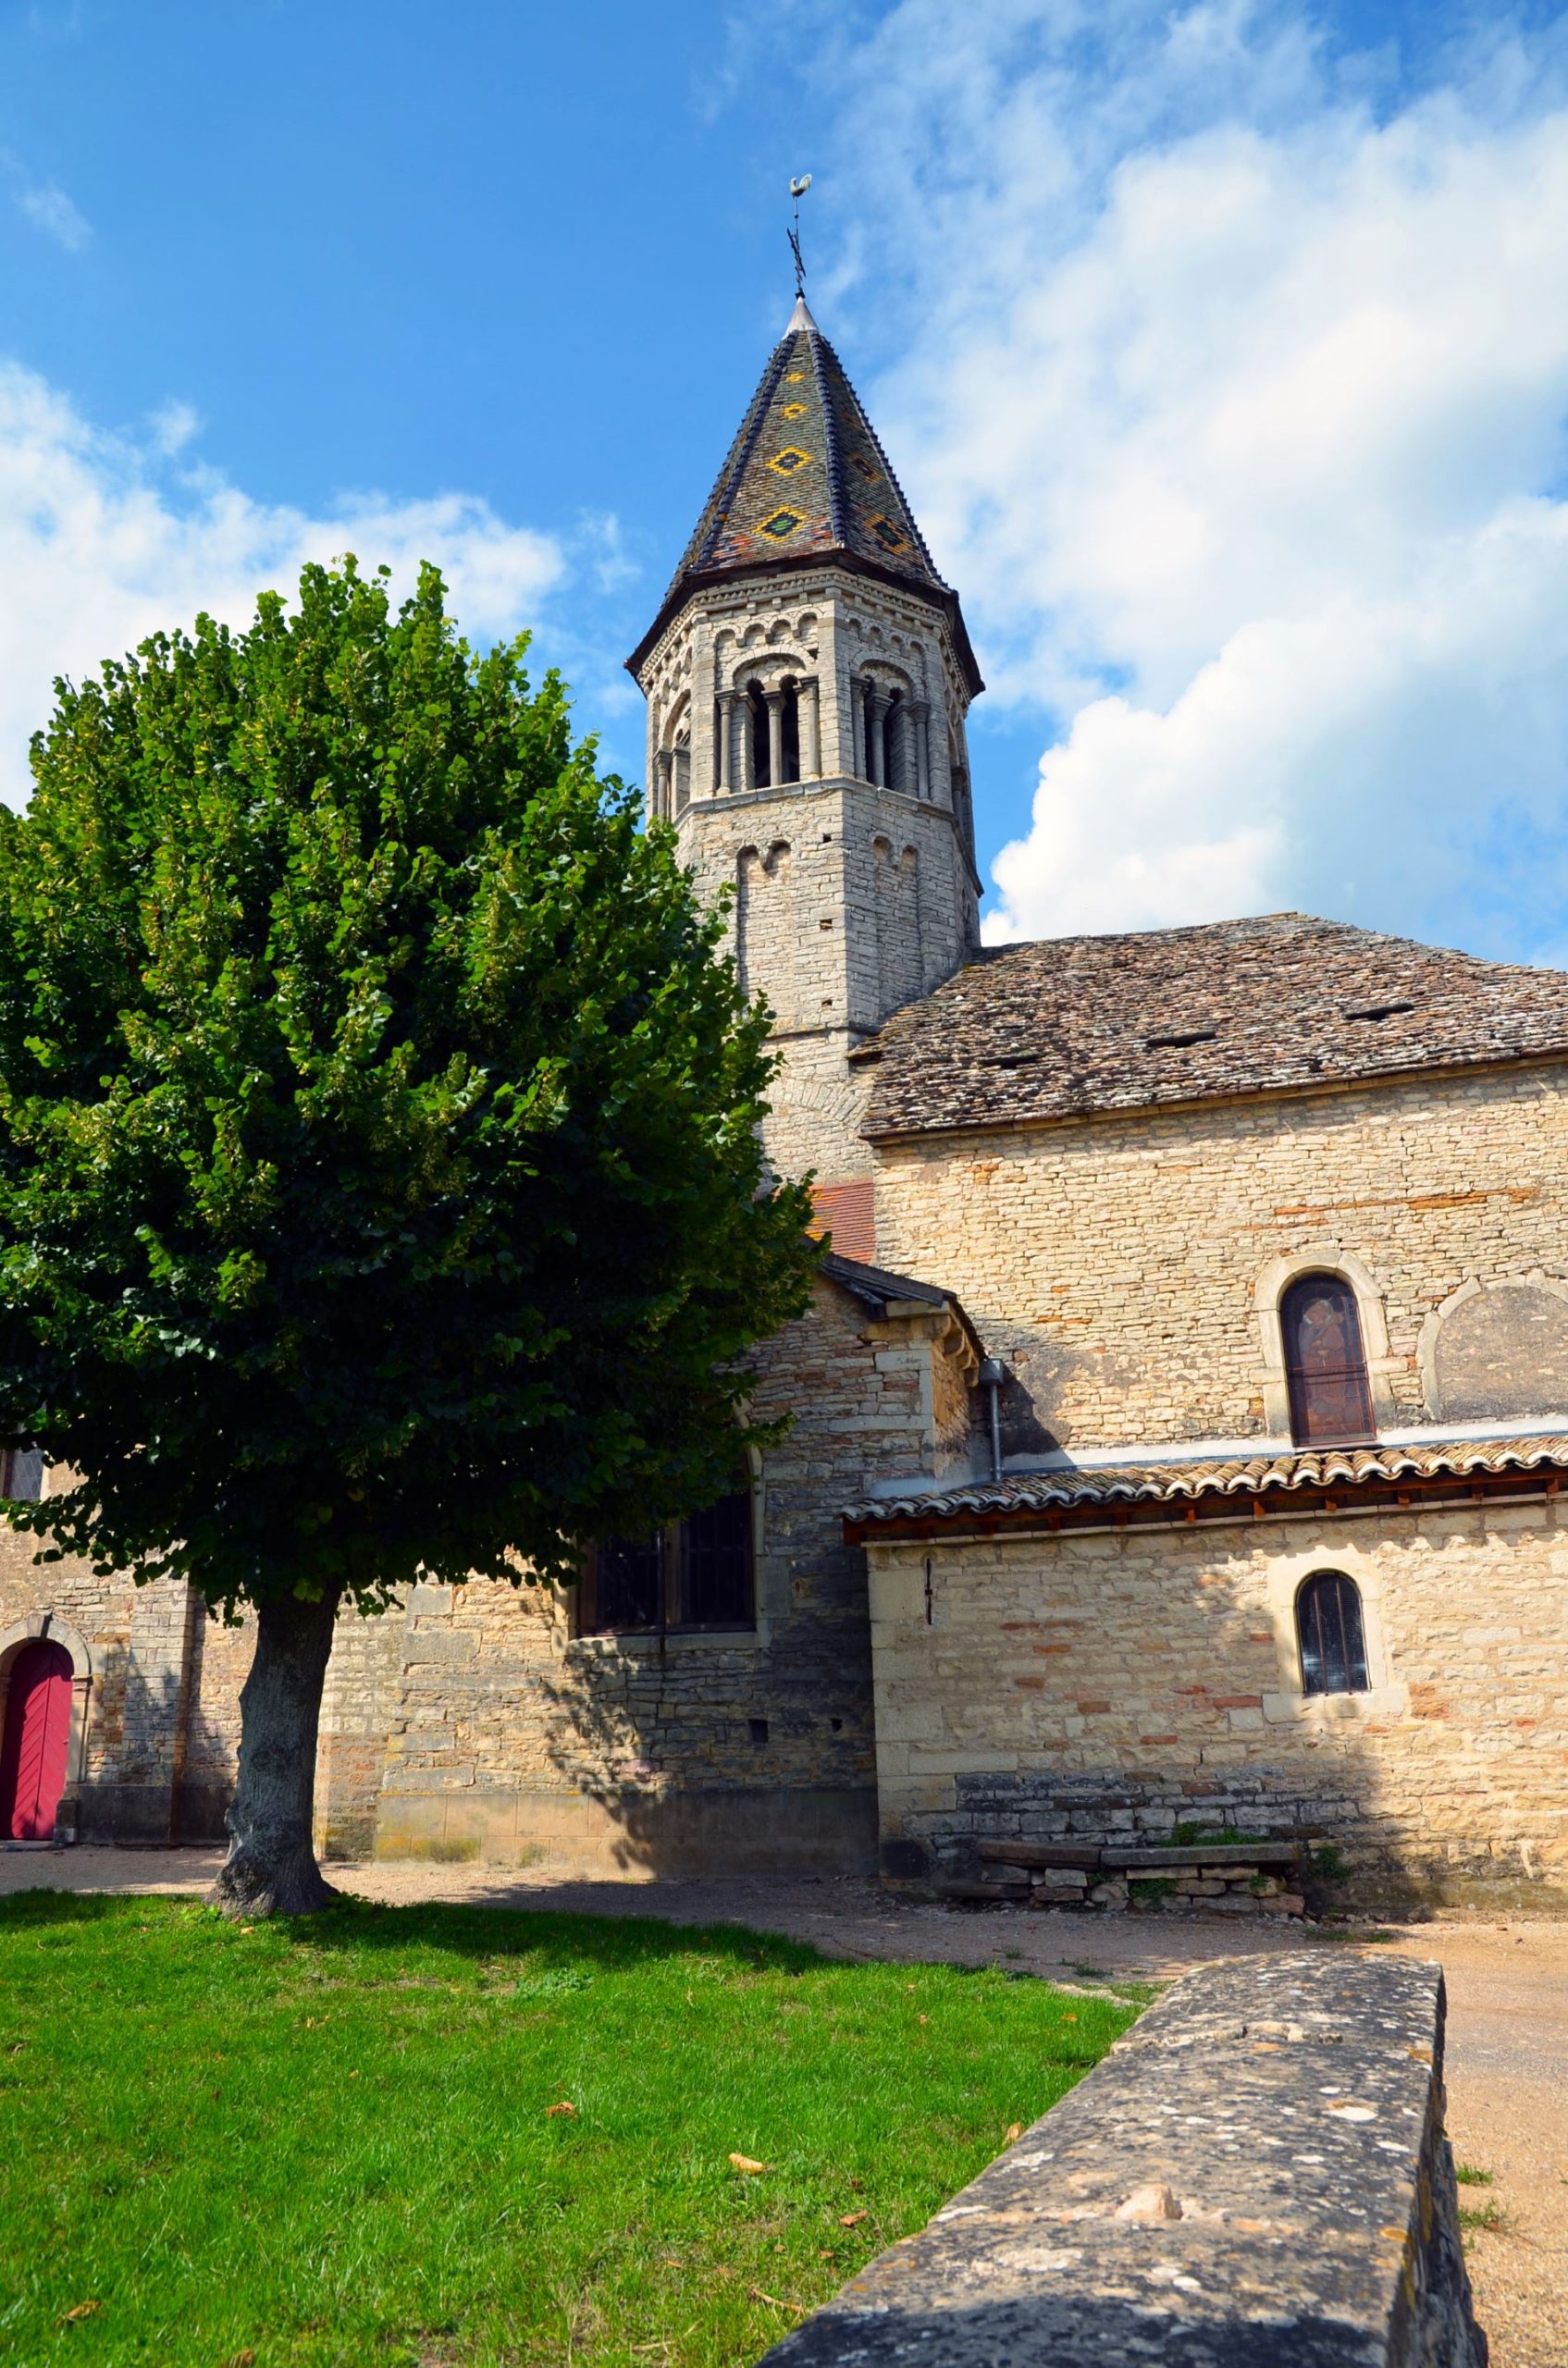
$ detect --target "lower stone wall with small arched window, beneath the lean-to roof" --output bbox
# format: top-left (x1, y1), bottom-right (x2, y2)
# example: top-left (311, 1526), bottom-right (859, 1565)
top-left (870, 1498), bottom-right (1568, 1887)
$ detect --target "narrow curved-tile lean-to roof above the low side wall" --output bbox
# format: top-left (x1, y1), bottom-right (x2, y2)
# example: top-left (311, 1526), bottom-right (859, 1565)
top-left (844, 1433), bottom-right (1568, 1530)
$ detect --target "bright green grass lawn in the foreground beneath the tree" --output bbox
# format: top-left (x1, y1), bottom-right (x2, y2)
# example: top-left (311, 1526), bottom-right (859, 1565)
top-left (0, 1892), bottom-right (1134, 2368)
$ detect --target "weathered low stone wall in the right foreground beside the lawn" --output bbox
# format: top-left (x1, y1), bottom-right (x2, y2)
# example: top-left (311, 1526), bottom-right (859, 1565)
top-left (768, 1951), bottom-right (1488, 2368)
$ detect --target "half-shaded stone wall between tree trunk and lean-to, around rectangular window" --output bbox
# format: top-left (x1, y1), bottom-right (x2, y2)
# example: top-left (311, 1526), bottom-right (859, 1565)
top-left (334, 1281), bottom-right (967, 1873)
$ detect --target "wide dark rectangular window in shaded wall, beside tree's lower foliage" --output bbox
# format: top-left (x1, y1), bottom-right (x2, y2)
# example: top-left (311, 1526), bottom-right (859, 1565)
top-left (578, 1487), bottom-right (756, 1636)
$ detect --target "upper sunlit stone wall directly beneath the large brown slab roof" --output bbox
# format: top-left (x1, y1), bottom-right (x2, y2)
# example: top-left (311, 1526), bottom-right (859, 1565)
top-left (876, 1063), bottom-right (1568, 1451)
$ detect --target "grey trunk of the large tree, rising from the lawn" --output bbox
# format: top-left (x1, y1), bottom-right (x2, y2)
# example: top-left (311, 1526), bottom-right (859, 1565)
top-left (208, 1596), bottom-right (341, 1916)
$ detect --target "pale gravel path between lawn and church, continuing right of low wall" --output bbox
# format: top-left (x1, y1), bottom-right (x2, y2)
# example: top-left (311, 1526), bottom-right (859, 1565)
top-left (0, 1847), bottom-right (1568, 2368)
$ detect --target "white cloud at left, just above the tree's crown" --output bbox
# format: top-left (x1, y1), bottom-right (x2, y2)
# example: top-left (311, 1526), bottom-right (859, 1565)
top-left (0, 363), bottom-right (566, 803)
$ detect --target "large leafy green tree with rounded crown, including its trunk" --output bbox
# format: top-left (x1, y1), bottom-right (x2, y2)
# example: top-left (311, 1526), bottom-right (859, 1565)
top-left (0, 561), bottom-right (815, 1913)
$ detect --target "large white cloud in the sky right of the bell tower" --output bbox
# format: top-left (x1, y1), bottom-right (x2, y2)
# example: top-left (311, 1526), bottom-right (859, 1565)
top-left (836, 0), bottom-right (1568, 955)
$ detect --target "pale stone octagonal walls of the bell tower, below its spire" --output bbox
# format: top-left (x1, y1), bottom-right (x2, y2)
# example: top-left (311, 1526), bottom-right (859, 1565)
top-left (658, 563), bottom-right (978, 1184)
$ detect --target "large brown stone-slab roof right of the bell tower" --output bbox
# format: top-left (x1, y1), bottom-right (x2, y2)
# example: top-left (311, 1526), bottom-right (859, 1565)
top-left (858, 912), bottom-right (1568, 1139)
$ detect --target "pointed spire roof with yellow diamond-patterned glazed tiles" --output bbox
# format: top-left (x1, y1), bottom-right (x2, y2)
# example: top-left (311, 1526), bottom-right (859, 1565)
top-left (663, 303), bottom-right (947, 609)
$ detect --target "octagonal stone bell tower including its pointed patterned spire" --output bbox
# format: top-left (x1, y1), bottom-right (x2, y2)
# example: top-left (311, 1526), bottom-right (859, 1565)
top-left (628, 299), bottom-right (983, 1212)
